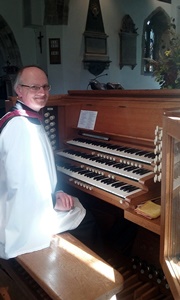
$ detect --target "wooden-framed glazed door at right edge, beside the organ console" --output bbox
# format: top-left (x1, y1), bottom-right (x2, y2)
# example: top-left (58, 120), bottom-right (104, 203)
top-left (160, 111), bottom-right (180, 300)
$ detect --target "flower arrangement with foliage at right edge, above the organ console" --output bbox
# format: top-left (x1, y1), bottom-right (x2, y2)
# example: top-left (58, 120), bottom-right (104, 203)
top-left (147, 23), bottom-right (180, 89)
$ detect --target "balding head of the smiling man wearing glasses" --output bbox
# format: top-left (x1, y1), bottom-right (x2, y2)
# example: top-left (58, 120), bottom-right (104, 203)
top-left (14, 66), bottom-right (50, 111)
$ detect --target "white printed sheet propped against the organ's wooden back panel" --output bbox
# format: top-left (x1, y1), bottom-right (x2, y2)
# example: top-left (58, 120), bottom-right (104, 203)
top-left (78, 110), bottom-right (98, 130)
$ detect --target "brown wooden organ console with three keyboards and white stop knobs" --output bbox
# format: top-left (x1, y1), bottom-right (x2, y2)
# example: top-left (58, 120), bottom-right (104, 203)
top-left (3, 90), bottom-right (180, 299)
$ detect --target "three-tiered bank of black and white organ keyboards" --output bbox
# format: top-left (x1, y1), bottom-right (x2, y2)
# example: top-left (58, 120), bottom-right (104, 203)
top-left (57, 134), bottom-right (159, 208)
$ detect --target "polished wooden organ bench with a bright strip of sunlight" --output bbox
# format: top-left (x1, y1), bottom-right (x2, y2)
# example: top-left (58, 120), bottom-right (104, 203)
top-left (16, 233), bottom-right (123, 300)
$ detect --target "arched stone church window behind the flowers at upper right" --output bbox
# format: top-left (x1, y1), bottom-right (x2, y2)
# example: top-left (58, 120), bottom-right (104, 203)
top-left (142, 7), bottom-right (170, 75)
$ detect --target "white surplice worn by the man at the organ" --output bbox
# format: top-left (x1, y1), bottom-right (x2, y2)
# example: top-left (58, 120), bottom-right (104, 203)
top-left (0, 117), bottom-right (86, 259)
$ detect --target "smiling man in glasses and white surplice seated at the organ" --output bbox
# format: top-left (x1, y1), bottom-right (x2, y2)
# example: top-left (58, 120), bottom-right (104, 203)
top-left (0, 66), bottom-right (101, 259)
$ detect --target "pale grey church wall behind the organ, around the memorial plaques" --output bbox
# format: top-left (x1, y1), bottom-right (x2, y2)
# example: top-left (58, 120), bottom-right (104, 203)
top-left (1, 0), bottom-right (178, 94)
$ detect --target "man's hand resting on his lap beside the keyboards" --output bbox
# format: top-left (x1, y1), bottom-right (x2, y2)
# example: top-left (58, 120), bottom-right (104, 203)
top-left (54, 191), bottom-right (74, 211)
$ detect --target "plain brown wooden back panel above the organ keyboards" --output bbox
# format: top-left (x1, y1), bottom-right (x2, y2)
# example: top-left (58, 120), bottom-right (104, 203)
top-left (48, 90), bottom-right (180, 146)
